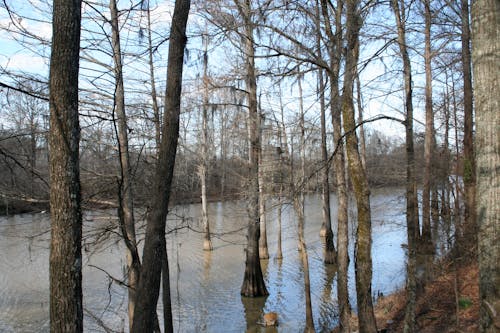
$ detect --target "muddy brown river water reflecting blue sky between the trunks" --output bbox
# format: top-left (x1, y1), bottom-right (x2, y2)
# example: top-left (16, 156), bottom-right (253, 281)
top-left (0, 189), bottom-right (406, 332)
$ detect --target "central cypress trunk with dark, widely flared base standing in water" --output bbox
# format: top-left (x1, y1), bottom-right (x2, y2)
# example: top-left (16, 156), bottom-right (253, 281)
top-left (239, 0), bottom-right (268, 297)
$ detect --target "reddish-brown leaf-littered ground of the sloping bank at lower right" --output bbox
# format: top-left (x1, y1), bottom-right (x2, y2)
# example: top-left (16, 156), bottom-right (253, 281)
top-left (333, 263), bottom-right (479, 333)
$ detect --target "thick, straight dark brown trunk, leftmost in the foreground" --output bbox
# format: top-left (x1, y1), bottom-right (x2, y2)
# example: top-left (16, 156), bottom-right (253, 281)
top-left (49, 0), bottom-right (83, 332)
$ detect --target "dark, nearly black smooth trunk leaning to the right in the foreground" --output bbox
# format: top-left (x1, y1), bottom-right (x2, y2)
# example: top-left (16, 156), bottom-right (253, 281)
top-left (131, 0), bottom-right (190, 333)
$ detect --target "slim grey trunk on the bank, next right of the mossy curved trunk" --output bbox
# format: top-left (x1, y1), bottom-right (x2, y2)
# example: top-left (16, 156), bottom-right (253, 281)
top-left (391, 0), bottom-right (419, 333)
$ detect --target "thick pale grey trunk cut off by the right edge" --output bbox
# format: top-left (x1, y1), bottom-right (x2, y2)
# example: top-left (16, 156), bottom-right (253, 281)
top-left (472, 0), bottom-right (500, 332)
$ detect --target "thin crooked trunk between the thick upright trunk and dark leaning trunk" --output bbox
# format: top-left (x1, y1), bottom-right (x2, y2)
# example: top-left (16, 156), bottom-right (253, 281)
top-left (109, 0), bottom-right (140, 327)
